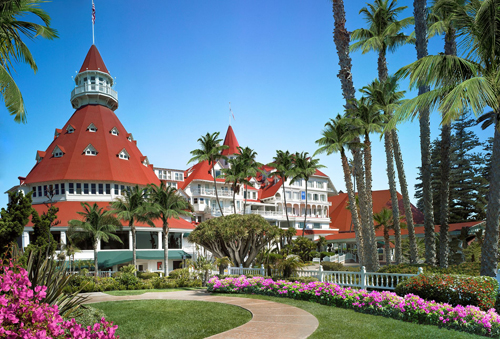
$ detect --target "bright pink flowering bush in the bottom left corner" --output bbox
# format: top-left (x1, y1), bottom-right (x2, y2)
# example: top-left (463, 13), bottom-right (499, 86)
top-left (0, 263), bottom-right (118, 339)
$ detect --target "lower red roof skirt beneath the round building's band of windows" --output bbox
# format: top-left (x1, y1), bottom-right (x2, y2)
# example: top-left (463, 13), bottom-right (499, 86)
top-left (27, 201), bottom-right (195, 230)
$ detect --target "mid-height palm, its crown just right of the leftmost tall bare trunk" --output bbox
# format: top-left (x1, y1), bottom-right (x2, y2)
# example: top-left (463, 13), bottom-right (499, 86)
top-left (350, 97), bottom-right (385, 270)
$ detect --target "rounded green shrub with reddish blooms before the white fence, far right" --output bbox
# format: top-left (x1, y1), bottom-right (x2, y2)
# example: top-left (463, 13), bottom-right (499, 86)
top-left (396, 274), bottom-right (498, 311)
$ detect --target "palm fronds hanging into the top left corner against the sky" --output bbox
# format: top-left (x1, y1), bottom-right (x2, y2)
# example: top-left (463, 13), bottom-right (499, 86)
top-left (0, 0), bottom-right (58, 123)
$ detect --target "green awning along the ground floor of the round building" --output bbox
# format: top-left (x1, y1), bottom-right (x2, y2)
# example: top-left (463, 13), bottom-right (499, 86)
top-left (97, 250), bottom-right (191, 268)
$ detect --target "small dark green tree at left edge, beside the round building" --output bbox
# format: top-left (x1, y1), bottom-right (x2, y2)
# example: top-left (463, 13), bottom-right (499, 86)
top-left (0, 192), bottom-right (32, 253)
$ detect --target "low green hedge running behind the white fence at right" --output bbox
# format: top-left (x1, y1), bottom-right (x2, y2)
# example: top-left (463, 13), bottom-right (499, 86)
top-left (379, 262), bottom-right (481, 276)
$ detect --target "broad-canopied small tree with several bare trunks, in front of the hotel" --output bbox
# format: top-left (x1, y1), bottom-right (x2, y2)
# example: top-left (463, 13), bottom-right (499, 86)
top-left (188, 214), bottom-right (279, 267)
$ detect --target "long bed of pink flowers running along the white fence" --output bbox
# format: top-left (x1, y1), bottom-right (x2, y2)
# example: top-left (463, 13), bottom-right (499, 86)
top-left (207, 276), bottom-right (500, 337)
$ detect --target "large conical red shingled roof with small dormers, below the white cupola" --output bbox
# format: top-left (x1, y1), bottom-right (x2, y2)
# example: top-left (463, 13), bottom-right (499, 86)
top-left (26, 105), bottom-right (160, 185)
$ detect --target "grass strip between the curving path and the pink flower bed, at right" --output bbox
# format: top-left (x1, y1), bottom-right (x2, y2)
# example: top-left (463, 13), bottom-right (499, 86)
top-left (214, 293), bottom-right (482, 339)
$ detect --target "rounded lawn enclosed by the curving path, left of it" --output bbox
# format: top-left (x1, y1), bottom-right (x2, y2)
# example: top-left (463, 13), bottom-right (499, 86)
top-left (92, 300), bottom-right (252, 339)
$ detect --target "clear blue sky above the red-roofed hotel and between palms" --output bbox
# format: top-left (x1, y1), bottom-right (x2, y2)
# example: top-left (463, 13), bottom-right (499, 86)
top-left (0, 0), bottom-right (493, 206)
